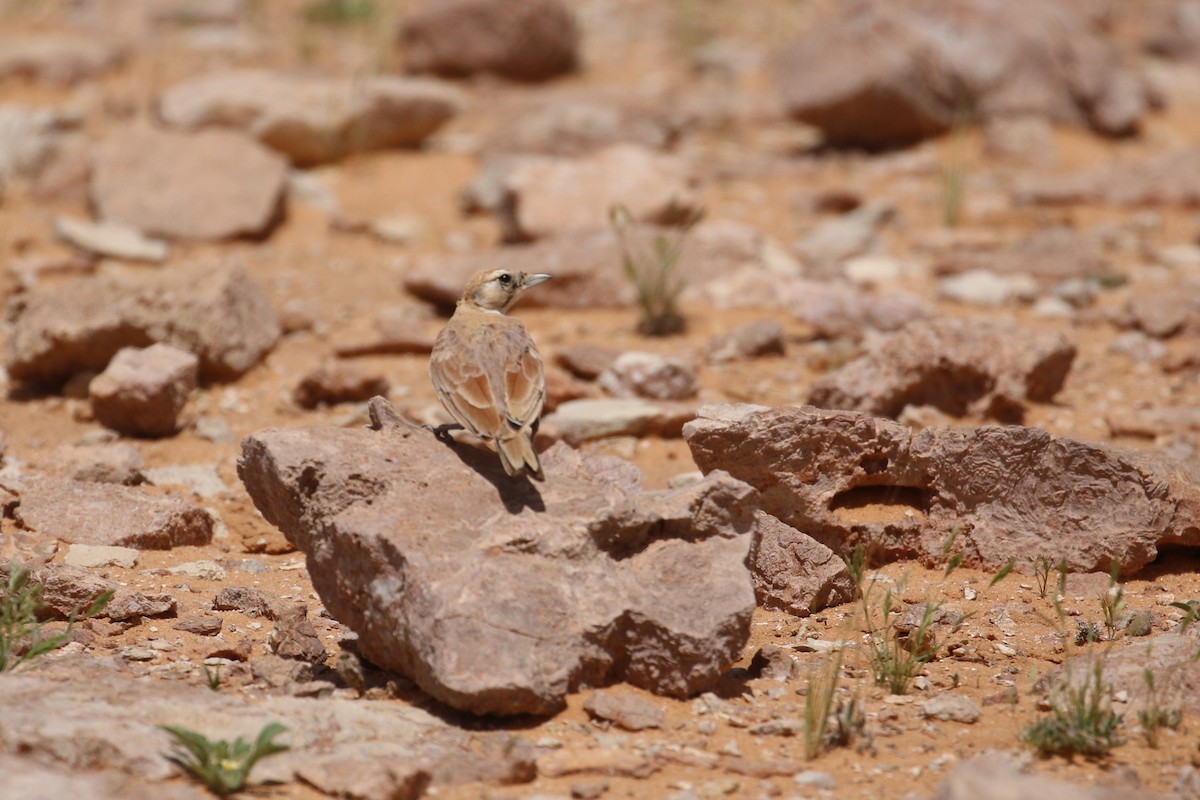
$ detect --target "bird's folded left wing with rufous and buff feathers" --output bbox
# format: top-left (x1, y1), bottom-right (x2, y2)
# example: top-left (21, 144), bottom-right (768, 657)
top-left (430, 329), bottom-right (504, 439)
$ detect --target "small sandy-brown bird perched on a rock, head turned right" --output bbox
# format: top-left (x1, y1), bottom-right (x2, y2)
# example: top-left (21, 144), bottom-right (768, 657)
top-left (430, 270), bottom-right (551, 480)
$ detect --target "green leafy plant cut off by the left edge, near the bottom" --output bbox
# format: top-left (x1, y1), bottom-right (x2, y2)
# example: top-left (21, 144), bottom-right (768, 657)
top-left (0, 561), bottom-right (113, 672)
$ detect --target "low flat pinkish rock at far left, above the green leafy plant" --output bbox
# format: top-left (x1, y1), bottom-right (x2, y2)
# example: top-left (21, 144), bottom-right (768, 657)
top-left (10, 479), bottom-right (212, 549)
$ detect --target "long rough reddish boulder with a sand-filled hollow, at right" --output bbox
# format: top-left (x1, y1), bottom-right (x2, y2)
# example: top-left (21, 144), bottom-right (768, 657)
top-left (684, 405), bottom-right (1200, 575)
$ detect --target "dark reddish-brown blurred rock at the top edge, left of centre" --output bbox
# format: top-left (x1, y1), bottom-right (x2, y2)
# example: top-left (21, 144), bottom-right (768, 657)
top-left (398, 0), bottom-right (580, 82)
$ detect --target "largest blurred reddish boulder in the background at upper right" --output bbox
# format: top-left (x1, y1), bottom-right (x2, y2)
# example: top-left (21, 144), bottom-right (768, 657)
top-left (780, 0), bottom-right (1150, 148)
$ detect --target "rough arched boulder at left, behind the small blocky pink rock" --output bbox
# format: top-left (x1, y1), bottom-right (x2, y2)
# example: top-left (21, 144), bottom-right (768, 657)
top-left (7, 264), bottom-right (280, 383)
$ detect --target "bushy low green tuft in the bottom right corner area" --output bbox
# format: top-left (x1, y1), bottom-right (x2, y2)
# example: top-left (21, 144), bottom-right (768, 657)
top-left (1021, 657), bottom-right (1124, 757)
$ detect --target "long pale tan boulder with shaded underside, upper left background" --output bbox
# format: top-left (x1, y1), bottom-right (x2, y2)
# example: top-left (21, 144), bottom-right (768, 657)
top-left (158, 70), bottom-right (466, 166)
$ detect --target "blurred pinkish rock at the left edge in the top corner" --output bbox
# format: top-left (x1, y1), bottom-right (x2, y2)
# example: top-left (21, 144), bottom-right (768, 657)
top-left (0, 34), bottom-right (122, 85)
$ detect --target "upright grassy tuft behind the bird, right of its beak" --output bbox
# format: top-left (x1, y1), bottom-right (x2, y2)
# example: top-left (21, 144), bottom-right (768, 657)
top-left (608, 205), bottom-right (702, 336)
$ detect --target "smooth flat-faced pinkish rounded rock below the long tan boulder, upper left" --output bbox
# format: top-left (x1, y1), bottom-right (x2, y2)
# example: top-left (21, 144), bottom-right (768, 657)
top-left (91, 124), bottom-right (287, 240)
